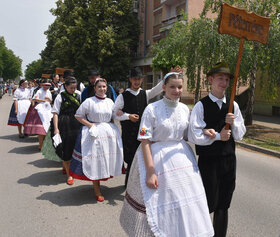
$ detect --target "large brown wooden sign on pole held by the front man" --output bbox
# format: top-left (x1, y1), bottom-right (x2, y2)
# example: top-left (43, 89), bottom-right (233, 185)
top-left (218, 3), bottom-right (270, 129)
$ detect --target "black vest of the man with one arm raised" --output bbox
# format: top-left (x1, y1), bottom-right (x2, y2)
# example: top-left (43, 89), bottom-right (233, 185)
top-left (121, 90), bottom-right (147, 139)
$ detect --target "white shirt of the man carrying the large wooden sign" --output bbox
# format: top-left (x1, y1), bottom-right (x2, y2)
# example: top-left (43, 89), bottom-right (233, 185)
top-left (188, 93), bottom-right (246, 146)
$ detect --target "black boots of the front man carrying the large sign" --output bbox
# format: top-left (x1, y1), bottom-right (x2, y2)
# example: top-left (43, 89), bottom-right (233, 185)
top-left (213, 210), bottom-right (228, 237)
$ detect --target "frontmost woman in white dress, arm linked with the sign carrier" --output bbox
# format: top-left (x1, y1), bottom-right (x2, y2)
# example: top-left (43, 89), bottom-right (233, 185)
top-left (120, 72), bottom-right (214, 237)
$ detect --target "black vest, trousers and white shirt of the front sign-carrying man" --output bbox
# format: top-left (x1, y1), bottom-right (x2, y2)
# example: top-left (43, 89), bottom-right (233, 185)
top-left (189, 93), bottom-right (246, 212)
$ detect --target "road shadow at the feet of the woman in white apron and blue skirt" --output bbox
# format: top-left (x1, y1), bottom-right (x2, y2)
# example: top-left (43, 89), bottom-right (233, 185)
top-left (37, 185), bottom-right (124, 206)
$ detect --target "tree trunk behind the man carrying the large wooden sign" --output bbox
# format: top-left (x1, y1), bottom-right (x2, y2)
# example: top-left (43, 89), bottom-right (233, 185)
top-left (245, 63), bottom-right (257, 126)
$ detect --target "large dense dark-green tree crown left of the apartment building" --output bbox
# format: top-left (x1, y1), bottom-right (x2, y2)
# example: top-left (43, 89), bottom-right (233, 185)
top-left (41, 0), bottom-right (140, 80)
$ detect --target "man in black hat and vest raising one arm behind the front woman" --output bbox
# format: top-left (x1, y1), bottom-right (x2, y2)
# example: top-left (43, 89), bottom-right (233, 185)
top-left (114, 67), bottom-right (162, 186)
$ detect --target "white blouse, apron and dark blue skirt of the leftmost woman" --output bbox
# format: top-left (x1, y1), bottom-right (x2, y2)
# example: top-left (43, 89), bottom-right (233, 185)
top-left (8, 87), bottom-right (31, 126)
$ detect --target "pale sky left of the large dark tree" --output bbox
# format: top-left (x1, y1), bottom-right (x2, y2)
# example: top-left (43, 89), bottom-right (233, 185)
top-left (0, 0), bottom-right (56, 73)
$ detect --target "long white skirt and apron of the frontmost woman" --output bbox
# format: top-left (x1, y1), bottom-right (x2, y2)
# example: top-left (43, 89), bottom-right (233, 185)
top-left (121, 141), bottom-right (214, 237)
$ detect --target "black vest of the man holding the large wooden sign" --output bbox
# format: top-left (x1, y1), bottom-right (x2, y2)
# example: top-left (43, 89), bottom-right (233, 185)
top-left (195, 96), bottom-right (235, 156)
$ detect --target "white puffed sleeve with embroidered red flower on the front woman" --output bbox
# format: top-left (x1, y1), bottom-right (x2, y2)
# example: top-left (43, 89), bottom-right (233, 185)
top-left (138, 104), bottom-right (155, 141)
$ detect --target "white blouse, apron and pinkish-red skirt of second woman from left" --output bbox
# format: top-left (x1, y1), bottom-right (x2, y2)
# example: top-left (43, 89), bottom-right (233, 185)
top-left (24, 88), bottom-right (52, 135)
